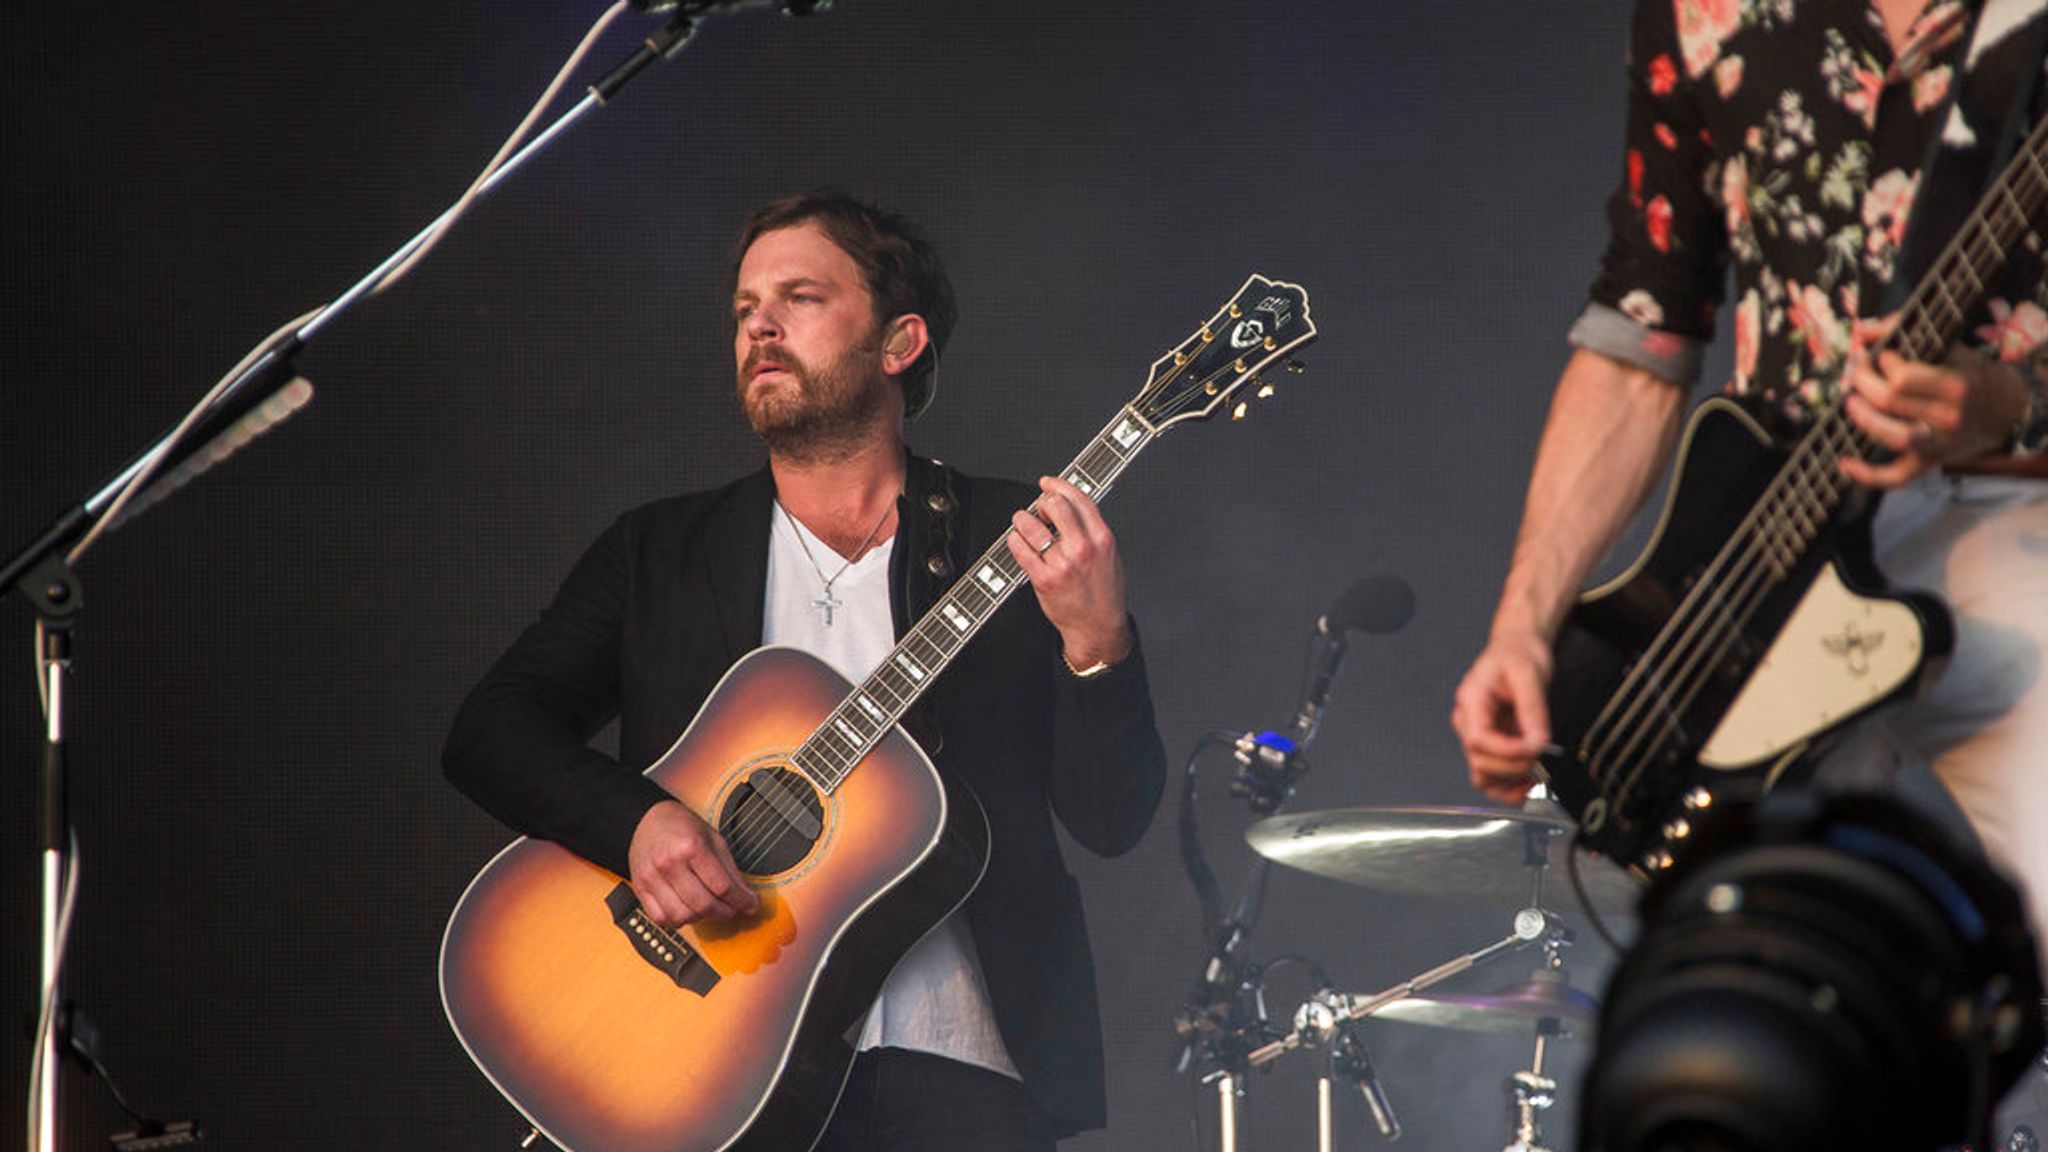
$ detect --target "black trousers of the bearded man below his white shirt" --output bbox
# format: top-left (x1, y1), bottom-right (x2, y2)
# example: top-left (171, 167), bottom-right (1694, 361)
top-left (813, 1047), bottom-right (1053, 1152)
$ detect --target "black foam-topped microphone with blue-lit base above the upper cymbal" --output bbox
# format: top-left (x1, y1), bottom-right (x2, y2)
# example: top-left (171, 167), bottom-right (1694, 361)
top-left (1231, 572), bottom-right (1415, 816)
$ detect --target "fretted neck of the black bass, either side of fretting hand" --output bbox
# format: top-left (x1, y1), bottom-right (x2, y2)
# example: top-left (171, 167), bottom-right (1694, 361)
top-left (1745, 117), bottom-right (2048, 570)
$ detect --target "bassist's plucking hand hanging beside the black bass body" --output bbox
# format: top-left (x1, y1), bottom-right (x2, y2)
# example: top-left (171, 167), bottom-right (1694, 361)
top-left (1450, 633), bottom-right (1550, 806)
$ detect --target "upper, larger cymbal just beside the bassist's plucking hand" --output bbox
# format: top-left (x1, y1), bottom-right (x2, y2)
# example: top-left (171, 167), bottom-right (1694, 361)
top-left (1245, 808), bottom-right (1640, 912)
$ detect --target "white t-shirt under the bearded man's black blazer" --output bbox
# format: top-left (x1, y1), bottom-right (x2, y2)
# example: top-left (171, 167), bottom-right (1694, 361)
top-left (762, 502), bottom-right (1020, 1078)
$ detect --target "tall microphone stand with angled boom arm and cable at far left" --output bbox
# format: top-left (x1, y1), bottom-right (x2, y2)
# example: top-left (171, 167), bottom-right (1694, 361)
top-left (0, 11), bottom-right (729, 1152)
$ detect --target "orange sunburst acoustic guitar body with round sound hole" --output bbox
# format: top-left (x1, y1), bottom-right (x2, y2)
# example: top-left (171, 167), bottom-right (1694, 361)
top-left (440, 648), bottom-right (987, 1152)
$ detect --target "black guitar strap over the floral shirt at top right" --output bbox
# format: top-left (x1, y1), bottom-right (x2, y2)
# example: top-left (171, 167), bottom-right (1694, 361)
top-left (1870, 0), bottom-right (2048, 316)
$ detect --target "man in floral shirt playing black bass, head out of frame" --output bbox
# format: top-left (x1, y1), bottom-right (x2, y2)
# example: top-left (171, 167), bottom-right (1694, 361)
top-left (1452, 0), bottom-right (2048, 967)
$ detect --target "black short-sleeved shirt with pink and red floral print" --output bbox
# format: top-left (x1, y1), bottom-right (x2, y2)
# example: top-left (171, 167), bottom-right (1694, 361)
top-left (1581, 0), bottom-right (2048, 426)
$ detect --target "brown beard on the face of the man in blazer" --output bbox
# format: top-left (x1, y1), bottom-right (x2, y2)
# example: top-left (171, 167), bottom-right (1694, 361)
top-left (737, 344), bottom-right (889, 463)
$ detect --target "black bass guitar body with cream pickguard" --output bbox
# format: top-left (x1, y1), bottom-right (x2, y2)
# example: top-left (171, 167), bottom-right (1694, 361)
top-left (1538, 400), bottom-right (1952, 869)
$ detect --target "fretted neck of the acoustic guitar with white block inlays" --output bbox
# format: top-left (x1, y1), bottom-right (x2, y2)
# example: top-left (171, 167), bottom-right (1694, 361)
top-left (791, 406), bottom-right (1159, 791)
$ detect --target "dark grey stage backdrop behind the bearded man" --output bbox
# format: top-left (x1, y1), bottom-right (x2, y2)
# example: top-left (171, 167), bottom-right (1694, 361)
top-left (0, 0), bottom-right (1695, 1152)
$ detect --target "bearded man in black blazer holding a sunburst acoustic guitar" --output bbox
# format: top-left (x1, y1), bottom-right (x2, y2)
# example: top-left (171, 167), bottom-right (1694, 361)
top-left (444, 191), bottom-right (1165, 1152)
